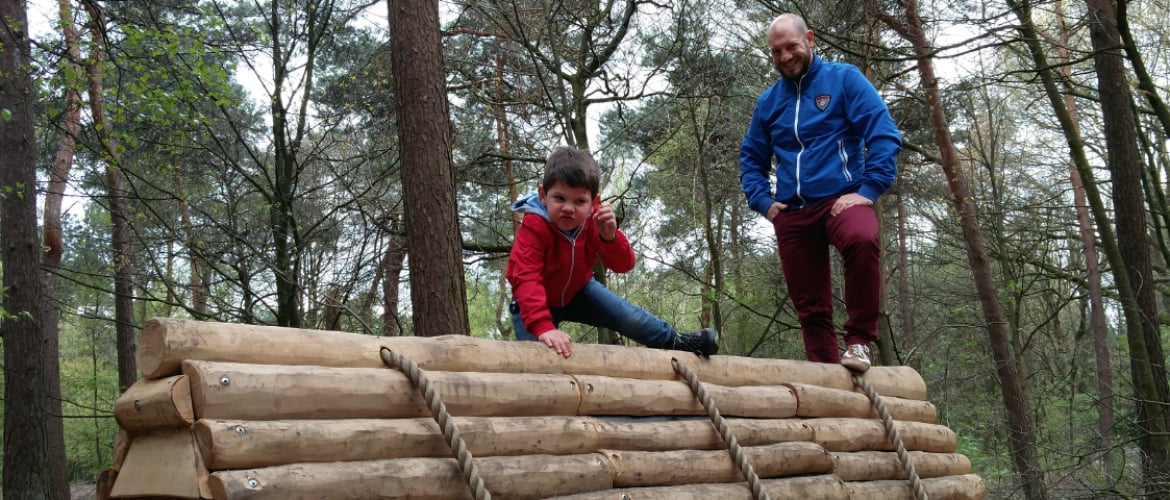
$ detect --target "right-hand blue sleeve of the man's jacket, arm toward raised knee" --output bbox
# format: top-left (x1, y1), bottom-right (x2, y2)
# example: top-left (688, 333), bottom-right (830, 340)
top-left (844, 67), bottom-right (902, 201)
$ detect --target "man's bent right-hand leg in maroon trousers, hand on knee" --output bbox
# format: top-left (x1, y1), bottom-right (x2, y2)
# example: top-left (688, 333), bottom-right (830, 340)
top-left (825, 206), bottom-right (882, 345)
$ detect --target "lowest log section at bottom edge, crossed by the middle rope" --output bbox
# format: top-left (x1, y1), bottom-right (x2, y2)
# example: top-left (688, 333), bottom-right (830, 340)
top-left (538, 474), bottom-right (851, 500)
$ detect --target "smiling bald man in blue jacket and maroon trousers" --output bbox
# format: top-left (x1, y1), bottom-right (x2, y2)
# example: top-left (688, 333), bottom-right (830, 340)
top-left (739, 14), bottom-right (902, 372)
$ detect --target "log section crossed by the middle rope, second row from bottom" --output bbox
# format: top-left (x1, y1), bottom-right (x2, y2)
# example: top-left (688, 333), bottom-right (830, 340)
top-left (603, 443), bottom-right (833, 487)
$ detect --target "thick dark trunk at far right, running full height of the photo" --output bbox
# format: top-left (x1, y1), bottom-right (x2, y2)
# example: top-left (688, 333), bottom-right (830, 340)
top-left (1086, 0), bottom-right (1170, 498)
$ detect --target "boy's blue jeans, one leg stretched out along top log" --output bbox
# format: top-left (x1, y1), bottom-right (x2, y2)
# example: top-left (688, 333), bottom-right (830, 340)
top-left (509, 280), bottom-right (679, 348)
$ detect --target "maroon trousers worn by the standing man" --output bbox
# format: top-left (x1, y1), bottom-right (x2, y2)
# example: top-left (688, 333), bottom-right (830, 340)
top-left (772, 198), bottom-right (882, 363)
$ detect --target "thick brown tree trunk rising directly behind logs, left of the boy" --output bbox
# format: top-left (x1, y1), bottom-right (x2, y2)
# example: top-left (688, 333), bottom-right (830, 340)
top-left (387, 0), bottom-right (470, 337)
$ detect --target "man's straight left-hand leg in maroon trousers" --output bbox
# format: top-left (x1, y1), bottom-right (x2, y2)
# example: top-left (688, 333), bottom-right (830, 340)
top-left (772, 201), bottom-right (841, 363)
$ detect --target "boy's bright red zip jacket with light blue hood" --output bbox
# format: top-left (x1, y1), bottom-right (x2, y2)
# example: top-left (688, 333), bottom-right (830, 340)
top-left (507, 194), bottom-right (634, 337)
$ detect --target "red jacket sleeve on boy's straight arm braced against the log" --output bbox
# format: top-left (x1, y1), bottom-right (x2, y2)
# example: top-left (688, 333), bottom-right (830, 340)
top-left (507, 214), bottom-right (556, 337)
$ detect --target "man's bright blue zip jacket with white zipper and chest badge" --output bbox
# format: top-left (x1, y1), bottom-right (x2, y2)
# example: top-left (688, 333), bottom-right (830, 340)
top-left (739, 55), bottom-right (902, 214)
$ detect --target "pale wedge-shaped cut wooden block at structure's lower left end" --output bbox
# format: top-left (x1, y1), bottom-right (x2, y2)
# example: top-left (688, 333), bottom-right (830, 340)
top-left (110, 429), bottom-right (211, 499)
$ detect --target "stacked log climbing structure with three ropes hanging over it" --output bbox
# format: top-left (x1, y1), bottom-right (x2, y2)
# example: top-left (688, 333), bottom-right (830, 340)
top-left (105, 319), bottom-right (985, 500)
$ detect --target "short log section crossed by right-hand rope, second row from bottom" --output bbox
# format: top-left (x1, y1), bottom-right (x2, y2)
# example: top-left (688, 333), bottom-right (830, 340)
top-left (833, 451), bottom-right (971, 481)
